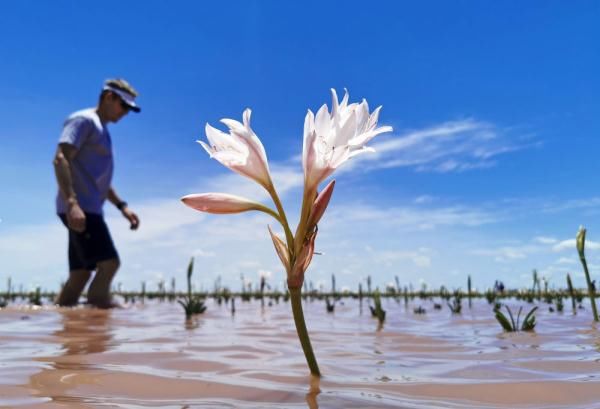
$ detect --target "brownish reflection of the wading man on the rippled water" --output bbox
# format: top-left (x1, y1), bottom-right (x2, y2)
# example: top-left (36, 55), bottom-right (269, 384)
top-left (29, 308), bottom-right (113, 403)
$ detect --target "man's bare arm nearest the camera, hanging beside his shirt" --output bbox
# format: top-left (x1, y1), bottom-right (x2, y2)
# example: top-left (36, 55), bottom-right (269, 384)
top-left (53, 143), bottom-right (85, 232)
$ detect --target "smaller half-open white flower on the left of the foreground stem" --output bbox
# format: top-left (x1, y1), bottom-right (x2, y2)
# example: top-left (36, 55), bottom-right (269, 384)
top-left (198, 108), bottom-right (273, 190)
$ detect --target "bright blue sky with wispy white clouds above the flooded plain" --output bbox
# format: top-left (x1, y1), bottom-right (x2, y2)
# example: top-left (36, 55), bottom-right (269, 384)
top-left (0, 1), bottom-right (600, 289)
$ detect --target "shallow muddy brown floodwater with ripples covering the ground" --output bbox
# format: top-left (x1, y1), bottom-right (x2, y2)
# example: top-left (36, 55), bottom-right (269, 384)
top-left (0, 299), bottom-right (600, 409)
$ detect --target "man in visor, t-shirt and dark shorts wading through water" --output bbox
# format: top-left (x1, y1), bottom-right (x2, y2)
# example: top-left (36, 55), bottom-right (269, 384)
top-left (54, 79), bottom-right (140, 308)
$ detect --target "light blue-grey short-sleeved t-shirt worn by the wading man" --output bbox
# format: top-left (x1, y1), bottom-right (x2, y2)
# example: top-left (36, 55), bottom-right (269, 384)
top-left (56, 108), bottom-right (114, 214)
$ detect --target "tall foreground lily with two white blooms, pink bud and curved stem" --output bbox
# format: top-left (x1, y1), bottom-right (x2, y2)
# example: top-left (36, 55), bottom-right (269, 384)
top-left (181, 89), bottom-right (392, 376)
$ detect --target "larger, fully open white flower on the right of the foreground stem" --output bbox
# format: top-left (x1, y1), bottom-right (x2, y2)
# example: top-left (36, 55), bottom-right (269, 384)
top-left (302, 89), bottom-right (392, 191)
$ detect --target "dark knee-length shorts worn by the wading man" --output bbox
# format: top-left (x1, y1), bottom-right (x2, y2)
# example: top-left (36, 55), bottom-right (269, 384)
top-left (58, 213), bottom-right (119, 271)
